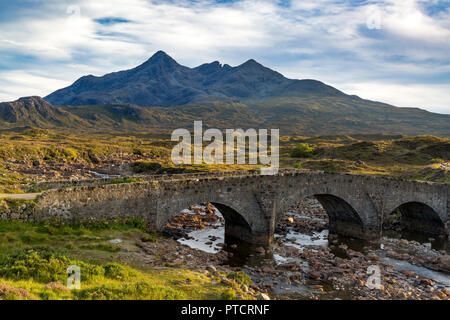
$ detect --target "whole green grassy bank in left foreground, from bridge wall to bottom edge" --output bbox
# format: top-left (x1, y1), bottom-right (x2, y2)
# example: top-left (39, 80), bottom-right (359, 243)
top-left (0, 221), bottom-right (251, 300)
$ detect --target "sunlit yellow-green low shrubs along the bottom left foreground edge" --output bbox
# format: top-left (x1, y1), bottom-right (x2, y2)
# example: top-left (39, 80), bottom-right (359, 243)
top-left (0, 249), bottom-right (243, 300)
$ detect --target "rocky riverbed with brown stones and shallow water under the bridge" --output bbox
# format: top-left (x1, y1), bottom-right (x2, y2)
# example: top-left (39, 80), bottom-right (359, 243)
top-left (157, 199), bottom-right (450, 300)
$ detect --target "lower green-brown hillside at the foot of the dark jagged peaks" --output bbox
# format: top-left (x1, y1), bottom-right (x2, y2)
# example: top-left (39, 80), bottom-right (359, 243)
top-left (0, 97), bottom-right (450, 137)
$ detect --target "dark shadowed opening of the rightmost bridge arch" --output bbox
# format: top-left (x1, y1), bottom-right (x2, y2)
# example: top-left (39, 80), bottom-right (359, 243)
top-left (383, 201), bottom-right (446, 236)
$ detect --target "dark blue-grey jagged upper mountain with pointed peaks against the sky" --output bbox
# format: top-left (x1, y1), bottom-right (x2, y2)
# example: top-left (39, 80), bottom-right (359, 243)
top-left (44, 51), bottom-right (345, 107)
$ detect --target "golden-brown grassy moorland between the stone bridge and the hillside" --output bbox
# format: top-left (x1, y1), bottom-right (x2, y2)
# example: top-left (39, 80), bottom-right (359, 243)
top-left (0, 128), bottom-right (450, 185)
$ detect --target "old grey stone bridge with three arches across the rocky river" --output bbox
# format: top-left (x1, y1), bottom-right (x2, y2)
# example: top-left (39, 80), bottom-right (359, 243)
top-left (33, 169), bottom-right (450, 244)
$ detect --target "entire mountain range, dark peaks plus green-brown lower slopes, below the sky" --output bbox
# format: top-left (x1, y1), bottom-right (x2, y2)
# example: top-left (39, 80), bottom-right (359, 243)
top-left (0, 51), bottom-right (450, 137)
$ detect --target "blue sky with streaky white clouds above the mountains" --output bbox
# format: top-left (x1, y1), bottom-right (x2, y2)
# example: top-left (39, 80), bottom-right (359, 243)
top-left (0, 0), bottom-right (450, 114)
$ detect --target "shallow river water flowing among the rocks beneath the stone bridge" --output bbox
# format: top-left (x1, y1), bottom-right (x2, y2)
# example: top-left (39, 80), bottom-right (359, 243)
top-left (174, 204), bottom-right (450, 299)
